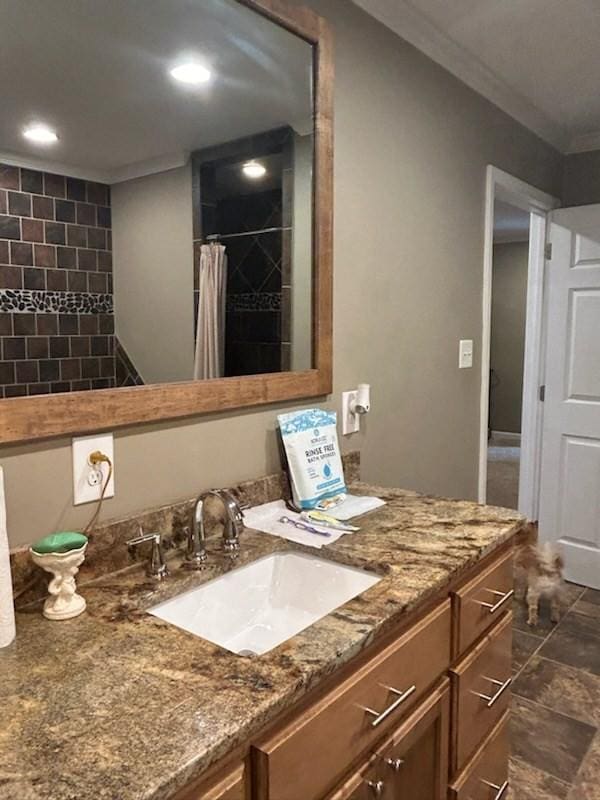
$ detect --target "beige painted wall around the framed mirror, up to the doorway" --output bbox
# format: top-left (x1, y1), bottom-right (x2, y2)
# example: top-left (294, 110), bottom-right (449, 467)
top-left (0, 0), bottom-right (561, 544)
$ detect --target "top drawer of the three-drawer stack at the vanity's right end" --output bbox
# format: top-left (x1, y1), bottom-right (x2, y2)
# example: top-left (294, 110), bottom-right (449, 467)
top-left (452, 550), bottom-right (513, 656)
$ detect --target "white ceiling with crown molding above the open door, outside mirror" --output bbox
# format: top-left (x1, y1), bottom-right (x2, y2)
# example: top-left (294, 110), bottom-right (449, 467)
top-left (354, 0), bottom-right (600, 152)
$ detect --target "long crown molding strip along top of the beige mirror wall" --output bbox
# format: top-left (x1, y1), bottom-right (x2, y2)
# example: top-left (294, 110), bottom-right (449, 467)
top-left (353, 0), bottom-right (568, 152)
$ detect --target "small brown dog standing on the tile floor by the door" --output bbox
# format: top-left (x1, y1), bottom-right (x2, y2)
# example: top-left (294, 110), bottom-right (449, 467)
top-left (514, 524), bottom-right (564, 626)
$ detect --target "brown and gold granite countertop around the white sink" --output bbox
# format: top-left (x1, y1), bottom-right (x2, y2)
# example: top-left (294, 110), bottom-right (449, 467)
top-left (0, 484), bottom-right (523, 800)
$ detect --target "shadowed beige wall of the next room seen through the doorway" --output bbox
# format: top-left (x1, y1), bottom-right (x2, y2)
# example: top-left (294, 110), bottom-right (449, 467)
top-left (490, 242), bottom-right (529, 433)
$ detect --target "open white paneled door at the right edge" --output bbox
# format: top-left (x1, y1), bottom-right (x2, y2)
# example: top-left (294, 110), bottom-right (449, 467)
top-left (540, 205), bottom-right (600, 589)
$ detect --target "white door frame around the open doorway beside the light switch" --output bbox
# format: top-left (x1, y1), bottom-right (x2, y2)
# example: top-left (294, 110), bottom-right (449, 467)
top-left (478, 164), bottom-right (560, 519)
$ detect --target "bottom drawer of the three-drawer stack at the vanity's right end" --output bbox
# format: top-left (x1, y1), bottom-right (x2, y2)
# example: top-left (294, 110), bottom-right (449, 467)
top-left (450, 712), bottom-right (510, 800)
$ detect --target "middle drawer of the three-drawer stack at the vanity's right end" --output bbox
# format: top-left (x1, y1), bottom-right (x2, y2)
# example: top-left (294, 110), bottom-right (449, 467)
top-left (450, 613), bottom-right (512, 770)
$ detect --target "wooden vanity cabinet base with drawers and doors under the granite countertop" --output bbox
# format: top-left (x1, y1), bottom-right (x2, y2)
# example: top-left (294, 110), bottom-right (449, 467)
top-left (171, 545), bottom-right (512, 800)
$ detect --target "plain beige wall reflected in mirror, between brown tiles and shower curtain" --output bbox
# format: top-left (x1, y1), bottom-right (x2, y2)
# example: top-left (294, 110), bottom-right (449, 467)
top-left (111, 163), bottom-right (194, 383)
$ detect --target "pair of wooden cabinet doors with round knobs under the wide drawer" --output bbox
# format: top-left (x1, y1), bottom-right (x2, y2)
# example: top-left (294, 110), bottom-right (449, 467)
top-left (327, 680), bottom-right (449, 800)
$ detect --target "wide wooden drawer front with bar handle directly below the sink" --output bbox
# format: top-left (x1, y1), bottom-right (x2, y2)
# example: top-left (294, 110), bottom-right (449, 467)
top-left (253, 601), bottom-right (450, 800)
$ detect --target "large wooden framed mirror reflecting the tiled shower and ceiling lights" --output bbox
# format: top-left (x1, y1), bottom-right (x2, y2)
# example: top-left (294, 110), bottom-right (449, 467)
top-left (0, 0), bottom-right (333, 442)
